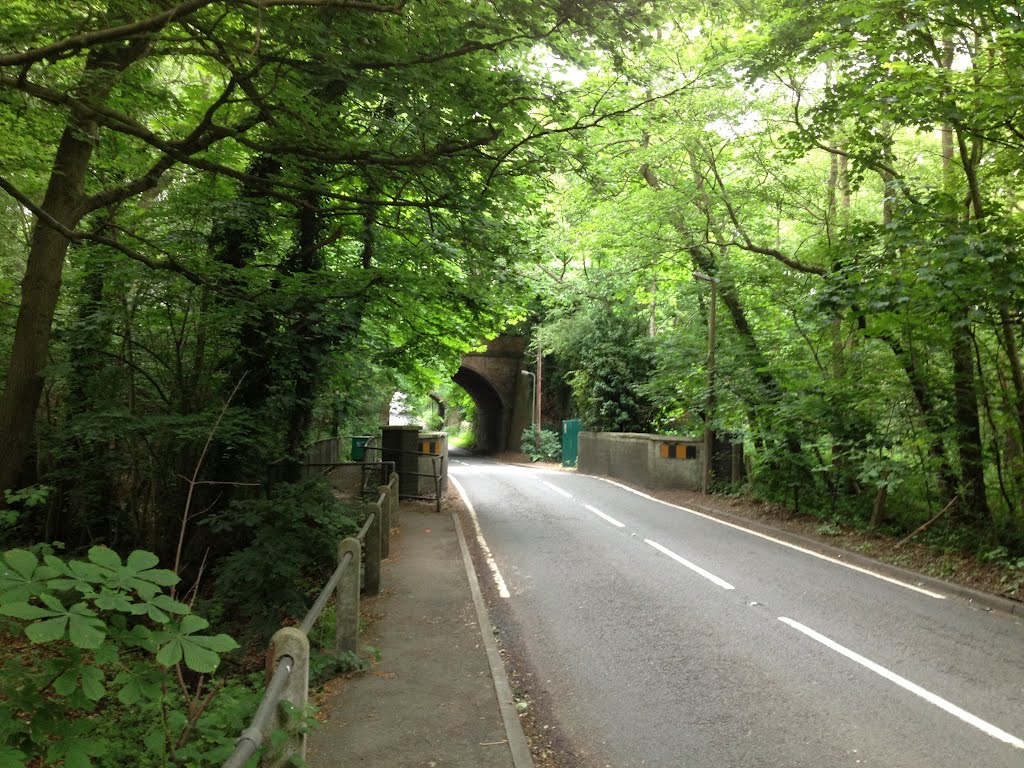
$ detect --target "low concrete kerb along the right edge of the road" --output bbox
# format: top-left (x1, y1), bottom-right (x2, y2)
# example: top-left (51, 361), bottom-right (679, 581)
top-left (592, 475), bottom-right (1024, 616)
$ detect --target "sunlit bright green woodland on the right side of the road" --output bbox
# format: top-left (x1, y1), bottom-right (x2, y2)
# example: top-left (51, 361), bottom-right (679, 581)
top-left (541, 2), bottom-right (1024, 557)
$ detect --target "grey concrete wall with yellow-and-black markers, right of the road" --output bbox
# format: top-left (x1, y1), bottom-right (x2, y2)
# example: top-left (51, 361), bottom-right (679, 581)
top-left (577, 432), bottom-right (703, 490)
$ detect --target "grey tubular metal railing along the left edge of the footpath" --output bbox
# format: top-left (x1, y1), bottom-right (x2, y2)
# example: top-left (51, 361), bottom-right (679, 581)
top-left (222, 474), bottom-right (398, 768)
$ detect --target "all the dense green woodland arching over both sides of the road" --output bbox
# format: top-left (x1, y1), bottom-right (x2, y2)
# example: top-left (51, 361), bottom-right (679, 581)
top-left (0, 0), bottom-right (1024, 765)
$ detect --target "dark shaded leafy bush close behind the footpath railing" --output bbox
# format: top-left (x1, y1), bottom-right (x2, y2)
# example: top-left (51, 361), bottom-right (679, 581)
top-left (206, 477), bottom-right (357, 640)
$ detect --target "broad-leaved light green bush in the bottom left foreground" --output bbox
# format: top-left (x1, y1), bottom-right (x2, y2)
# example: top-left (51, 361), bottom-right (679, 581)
top-left (0, 545), bottom-right (249, 768)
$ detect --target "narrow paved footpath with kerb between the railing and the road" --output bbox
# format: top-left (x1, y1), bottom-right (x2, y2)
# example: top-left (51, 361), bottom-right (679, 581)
top-left (306, 507), bottom-right (532, 768)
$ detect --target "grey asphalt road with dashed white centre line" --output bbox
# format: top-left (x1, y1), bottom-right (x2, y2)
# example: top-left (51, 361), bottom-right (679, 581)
top-left (451, 458), bottom-right (1024, 768)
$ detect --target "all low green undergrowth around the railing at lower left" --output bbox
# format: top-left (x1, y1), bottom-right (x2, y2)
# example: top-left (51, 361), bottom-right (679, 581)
top-left (0, 478), bottom-right (366, 768)
